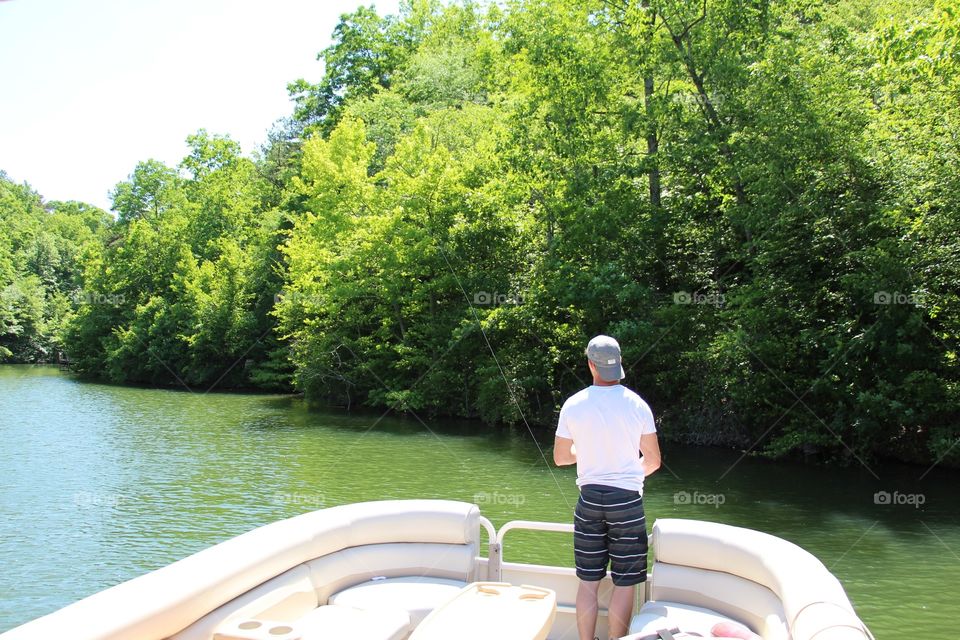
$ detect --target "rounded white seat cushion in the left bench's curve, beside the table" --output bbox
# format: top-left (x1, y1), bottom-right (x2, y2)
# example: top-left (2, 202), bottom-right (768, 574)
top-left (330, 576), bottom-right (467, 627)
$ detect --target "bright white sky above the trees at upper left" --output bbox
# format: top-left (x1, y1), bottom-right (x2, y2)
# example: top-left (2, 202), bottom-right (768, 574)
top-left (0, 0), bottom-right (399, 209)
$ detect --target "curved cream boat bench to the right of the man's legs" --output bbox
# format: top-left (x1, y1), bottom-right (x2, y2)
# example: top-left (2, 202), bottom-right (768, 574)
top-left (624, 518), bottom-right (870, 640)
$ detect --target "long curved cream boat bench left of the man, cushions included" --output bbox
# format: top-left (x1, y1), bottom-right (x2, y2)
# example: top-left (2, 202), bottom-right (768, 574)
top-left (4, 500), bottom-right (480, 640)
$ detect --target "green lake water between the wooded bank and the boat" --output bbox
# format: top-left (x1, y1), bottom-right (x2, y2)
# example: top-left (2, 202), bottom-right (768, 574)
top-left (0, 366), bottom-right (960, 638)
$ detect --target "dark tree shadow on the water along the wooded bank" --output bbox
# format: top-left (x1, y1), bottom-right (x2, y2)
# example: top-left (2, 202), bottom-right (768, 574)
top-left (253, 396), bottom-right (960, 537)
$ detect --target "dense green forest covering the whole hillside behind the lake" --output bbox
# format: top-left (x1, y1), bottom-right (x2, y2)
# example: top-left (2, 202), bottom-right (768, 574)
top-left (0, 0), bottom-right (960, 466)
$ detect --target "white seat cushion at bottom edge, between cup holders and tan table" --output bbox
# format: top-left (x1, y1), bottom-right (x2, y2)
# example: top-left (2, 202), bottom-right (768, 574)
top-left (292, 605), bottom-right (413, 640)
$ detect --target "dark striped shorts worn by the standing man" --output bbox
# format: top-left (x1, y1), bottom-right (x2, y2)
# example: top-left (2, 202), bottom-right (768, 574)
top-left (573, 484), bottom-right (647, 587)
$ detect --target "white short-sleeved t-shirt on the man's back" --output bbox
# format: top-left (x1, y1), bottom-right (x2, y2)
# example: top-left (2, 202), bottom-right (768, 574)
top-left (557, 384), bottom-right (657, 495)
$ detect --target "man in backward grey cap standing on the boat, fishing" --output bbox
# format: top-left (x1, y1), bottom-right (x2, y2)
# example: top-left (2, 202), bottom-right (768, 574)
top-left (553, 335), bottom-right (660, 640)
